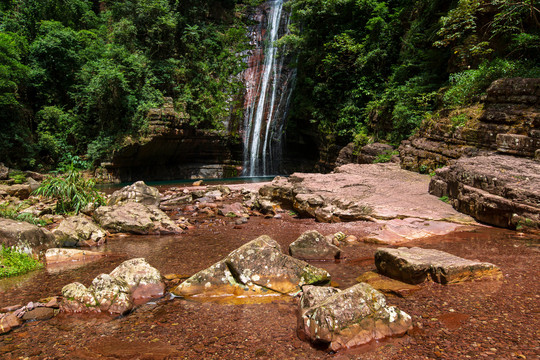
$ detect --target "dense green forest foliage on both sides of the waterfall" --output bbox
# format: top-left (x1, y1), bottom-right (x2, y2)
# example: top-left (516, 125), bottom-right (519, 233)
top-left (0, 0), bottom-right (540, 170)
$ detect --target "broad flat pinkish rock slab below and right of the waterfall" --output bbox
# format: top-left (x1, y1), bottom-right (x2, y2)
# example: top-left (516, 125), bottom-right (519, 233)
top-left (259, 163), bottom-right (474, 223)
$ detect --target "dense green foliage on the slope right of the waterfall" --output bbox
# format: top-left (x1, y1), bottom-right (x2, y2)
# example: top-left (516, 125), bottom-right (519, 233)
top-left (281, 0), bottom-right (540, 143)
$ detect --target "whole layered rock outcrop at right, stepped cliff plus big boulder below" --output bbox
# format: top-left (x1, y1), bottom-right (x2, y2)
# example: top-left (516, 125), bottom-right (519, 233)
top-left (399, 78), bottom-right (540, 232)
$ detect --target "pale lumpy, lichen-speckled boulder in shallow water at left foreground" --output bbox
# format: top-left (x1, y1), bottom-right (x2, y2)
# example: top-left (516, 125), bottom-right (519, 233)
top-left (60, 258), bottom-right (165, 314)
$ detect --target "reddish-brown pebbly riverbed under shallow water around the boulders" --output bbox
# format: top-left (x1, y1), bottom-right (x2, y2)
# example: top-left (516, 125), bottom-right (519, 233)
top-left (0, 213), bottom-right (540, 359)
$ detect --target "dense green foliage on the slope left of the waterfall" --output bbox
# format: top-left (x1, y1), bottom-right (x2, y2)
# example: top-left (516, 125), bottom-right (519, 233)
top-left (0, 0), bottom-right (258, 167)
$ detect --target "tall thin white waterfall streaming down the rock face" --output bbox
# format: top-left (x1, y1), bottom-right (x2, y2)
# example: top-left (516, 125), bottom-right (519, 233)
top-left (243, 0), bottom-right (296, 176)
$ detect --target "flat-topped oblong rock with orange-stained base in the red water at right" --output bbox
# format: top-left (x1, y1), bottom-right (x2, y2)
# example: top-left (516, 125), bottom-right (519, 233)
top-left (375, 247), bottom-right (502, 284)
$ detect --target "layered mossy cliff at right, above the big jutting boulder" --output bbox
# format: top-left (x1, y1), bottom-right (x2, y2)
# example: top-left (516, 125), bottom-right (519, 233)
top-left (399, 78), bottom-right (540, 172)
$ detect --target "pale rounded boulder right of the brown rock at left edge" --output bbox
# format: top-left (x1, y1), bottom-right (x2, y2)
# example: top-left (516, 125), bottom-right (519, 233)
top-left (53, 215), bottom-right (107, 247)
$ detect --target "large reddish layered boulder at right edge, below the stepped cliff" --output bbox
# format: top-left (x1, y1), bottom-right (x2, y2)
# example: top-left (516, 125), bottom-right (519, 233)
top-left (429, 155), bottom-right (540, 231)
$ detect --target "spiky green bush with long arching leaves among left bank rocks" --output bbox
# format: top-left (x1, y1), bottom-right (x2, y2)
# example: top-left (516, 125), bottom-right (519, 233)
top-left (34, 170), bottom-right (105, 213)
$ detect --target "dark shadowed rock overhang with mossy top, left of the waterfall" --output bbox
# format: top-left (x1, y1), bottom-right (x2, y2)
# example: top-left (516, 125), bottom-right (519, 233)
top-left (104, 99), bottom-right (242, 181)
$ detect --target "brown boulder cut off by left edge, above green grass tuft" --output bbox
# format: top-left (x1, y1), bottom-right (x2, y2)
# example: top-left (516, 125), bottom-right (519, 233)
top-left (0, 218), bottom-right (57, 253)
